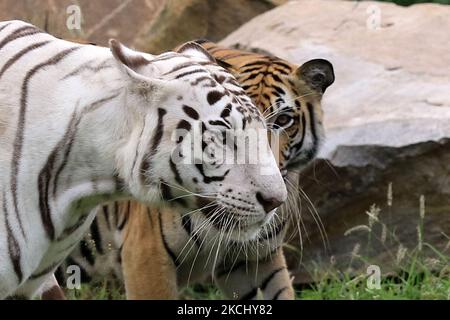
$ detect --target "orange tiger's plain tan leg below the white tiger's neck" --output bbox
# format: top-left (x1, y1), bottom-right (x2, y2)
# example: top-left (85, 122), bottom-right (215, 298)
top-left (122, 203), bottom-right (178, 300)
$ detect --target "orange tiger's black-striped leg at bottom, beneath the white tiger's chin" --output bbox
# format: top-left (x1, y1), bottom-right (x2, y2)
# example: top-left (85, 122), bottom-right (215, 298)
top-left (215, 248), bottom-right (295, 300)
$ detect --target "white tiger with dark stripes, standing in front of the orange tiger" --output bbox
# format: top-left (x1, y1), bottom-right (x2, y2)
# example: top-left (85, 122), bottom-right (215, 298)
top-left (0, 21), bottom-right (287, 298)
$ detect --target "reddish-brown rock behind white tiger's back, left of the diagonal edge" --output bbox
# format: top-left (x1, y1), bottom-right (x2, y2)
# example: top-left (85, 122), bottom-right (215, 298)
top-left (0, 0), bottom-right (166, 46)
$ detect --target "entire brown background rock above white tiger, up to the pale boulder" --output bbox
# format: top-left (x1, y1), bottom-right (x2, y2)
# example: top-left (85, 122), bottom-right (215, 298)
top-left (0, 0), bottom-right (287, 53)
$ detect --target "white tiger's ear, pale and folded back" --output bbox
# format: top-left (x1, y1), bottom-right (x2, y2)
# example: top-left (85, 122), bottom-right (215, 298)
top-left (109, 39), bottom-right (167, 96)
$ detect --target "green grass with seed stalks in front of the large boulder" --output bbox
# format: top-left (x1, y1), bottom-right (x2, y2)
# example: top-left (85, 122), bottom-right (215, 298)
top-left (298, 200), bottom-right (450, 300)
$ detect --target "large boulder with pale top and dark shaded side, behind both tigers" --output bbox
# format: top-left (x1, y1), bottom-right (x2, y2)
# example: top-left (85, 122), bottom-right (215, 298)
top-left (222, 0), bottom-right (450, 282)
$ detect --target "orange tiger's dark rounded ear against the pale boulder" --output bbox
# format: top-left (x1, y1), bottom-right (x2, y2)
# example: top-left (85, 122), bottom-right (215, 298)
top-left (295, 59), bottom-right (334, 93)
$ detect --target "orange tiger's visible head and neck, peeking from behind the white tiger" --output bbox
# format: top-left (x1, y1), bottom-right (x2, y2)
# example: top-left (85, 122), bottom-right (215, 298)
top-left (200, 41), bottom-right (334, 176)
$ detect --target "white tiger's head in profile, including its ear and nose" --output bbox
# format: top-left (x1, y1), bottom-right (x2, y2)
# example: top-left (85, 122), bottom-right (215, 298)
top-left (110, 40), bottom-right (287, 232)
